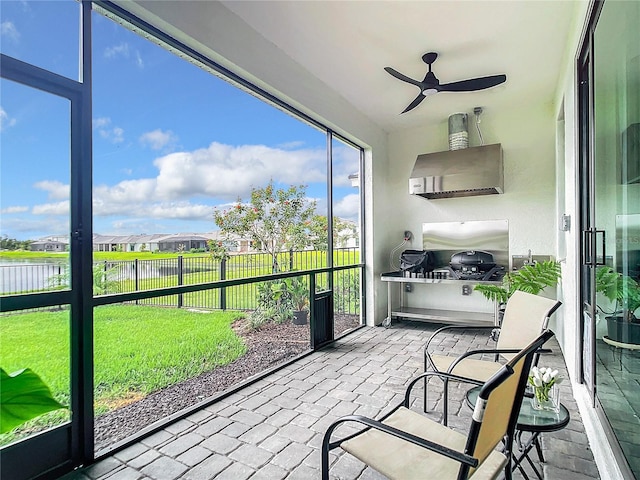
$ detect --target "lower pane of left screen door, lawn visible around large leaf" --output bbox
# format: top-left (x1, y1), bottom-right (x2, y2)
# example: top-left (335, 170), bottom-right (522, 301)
top-left (0, 306), bottom-right (71, 446)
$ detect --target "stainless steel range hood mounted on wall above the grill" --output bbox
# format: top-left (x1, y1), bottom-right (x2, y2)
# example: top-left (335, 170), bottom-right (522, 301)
top-left (409, 143), bottom-right (504, 199)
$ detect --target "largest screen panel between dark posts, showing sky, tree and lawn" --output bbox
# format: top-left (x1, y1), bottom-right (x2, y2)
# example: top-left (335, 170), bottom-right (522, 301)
top-left (92, 11), bottom-right (327, 453)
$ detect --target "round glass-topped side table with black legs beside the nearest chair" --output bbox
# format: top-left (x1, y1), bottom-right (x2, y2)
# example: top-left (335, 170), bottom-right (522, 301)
top-left (466, 386), bottom-right (570, 480)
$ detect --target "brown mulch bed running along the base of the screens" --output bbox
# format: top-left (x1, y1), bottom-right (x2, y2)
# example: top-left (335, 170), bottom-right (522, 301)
top-left (95, 315), bottom-right (359, 451)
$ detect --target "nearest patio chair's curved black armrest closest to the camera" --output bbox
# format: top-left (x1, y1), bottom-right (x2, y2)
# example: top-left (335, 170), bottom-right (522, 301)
top-left (322, 415), bottom-right (479, 467)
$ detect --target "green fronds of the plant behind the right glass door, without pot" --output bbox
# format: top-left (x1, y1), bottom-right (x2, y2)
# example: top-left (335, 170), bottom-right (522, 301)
top-left (596, 266), bottom-right (640, 323)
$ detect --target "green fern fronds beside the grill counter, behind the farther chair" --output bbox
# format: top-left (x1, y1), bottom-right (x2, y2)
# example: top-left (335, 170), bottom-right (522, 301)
top-left (474, 260), bottom-right (562, 303)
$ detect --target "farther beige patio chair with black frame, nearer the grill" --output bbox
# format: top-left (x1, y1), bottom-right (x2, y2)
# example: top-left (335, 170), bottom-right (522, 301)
top-left (424, 291), bottom-right (562, 425)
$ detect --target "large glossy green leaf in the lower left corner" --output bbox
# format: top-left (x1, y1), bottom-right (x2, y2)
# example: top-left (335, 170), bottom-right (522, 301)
top-left (0, 368), bottom-right (67, 433)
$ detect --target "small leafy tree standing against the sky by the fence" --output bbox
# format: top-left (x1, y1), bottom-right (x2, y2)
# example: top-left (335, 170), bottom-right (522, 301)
top-left (213, 180), bottom-right (316, 272)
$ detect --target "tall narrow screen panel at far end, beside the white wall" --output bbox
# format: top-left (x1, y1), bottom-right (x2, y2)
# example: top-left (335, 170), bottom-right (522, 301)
top-left (331, 137), bottom-right (362, 338)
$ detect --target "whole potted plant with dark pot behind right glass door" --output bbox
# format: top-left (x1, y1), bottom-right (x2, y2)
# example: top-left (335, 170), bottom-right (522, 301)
top-left (596, 266), bottom-right (640, 345)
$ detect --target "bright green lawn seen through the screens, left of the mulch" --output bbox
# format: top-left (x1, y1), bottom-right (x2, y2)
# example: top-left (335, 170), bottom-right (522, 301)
top-left (0, 305), bottom-right (246, 444)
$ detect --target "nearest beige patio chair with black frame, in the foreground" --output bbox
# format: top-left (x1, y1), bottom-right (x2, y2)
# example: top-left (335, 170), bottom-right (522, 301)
top-left (322, 330), bottom-right (553, 480)
